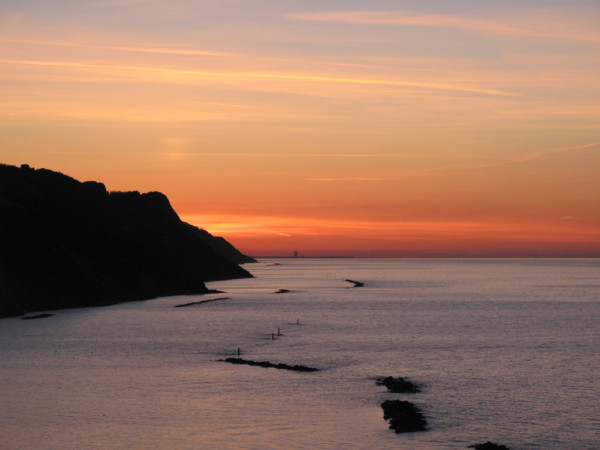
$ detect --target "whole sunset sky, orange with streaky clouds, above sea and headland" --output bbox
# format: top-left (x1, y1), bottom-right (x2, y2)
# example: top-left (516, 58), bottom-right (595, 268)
top-left (0, 0), bottom-right (600, 257)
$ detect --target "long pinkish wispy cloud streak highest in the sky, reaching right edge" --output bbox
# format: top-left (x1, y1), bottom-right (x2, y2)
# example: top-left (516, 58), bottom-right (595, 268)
top-left (284, 11), bottom-right (600, 42)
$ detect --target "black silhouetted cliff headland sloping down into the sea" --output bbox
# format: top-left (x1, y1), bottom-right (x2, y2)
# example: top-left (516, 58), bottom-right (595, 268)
top-left (0, 165), bottom-right (251, 317)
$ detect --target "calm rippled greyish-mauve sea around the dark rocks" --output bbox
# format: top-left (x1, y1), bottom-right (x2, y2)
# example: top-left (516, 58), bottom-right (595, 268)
top-left (0, 258), bottom-right (600, 449)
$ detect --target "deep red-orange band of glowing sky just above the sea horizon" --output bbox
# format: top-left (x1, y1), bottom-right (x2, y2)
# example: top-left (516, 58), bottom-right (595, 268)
top-left (182, 215), bottom-right (600, 257)
